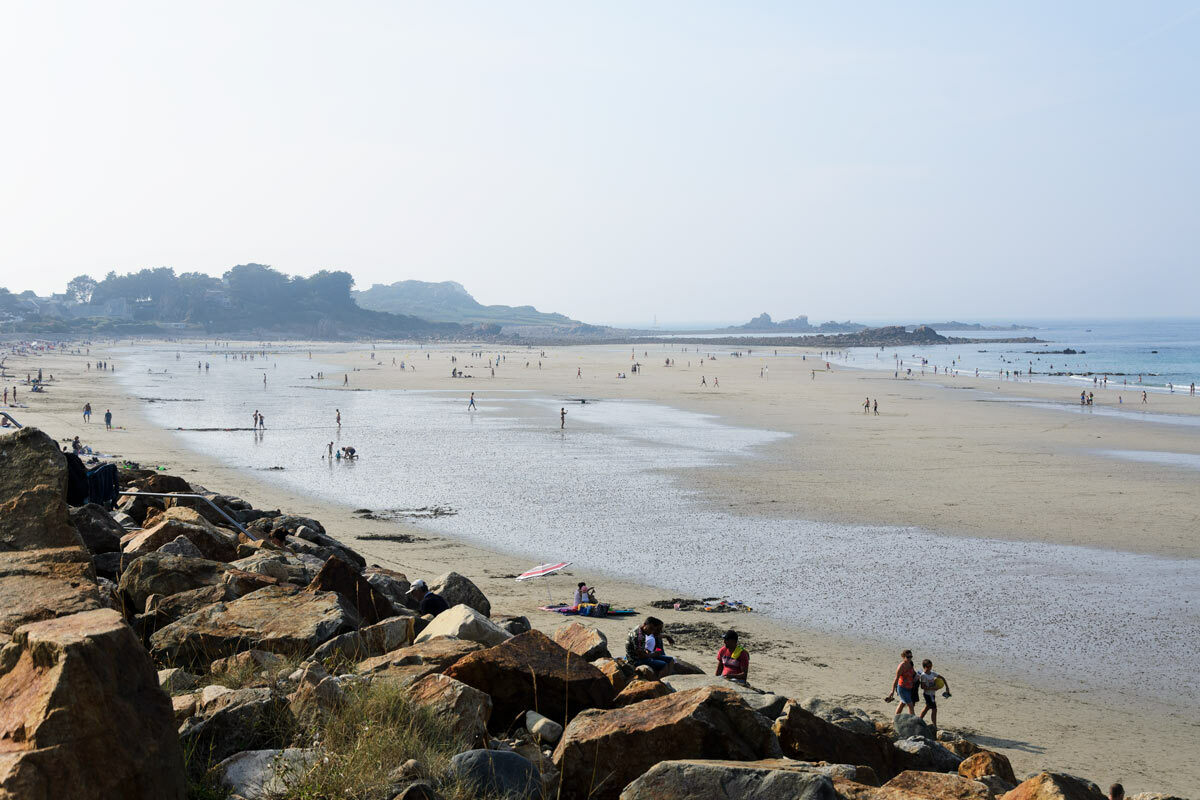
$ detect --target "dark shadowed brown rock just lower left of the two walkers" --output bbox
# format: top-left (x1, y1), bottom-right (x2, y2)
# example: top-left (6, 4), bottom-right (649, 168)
top-left (774, 702), bottom-right (916, 780)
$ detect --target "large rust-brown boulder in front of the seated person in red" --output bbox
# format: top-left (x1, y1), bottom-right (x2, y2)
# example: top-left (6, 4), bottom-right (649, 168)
top-left (549, 686), bottom-right (780, 800)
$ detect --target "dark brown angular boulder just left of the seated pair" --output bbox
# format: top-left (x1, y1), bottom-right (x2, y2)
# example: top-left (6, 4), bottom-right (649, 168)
top-left (444, 628), bottom-right (612, 733)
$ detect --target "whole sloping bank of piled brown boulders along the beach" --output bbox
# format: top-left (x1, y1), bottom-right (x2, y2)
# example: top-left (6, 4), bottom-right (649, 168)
top-left (0, 431), bottom-right (1185, 800)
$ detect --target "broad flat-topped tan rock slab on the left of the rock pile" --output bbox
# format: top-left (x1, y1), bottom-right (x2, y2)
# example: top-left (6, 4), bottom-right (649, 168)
top-left (150, 587), bottom-right (358, 666)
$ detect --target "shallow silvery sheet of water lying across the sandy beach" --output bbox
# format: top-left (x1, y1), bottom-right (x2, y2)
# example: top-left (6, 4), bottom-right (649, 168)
top-left (118, 349), bottom-right (1200, 706)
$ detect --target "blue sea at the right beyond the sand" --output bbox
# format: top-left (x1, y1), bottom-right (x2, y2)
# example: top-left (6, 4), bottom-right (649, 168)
top-left (840, 319), bottom-right (1200, 395)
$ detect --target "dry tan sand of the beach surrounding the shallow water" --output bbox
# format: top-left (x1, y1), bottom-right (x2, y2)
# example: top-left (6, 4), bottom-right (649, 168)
top-left (5, 342), bottom-right (1200, 794)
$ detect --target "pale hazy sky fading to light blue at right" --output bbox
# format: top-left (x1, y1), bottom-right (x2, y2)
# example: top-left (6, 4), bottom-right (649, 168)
top-left (0, 0), bottom-right (1200, 323)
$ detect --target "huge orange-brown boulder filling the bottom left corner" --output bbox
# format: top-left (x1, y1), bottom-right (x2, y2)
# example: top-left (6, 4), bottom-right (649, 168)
top-left (0, 609), bottom-right (186, 800)
